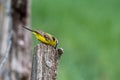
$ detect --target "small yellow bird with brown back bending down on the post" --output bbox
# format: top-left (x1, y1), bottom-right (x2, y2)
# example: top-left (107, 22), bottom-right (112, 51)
top-left (23, 26), bottom-right (58, 48)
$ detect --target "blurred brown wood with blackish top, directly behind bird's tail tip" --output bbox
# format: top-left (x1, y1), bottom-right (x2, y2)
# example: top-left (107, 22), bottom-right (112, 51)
top-left (10, 0), bottom-right (31, 80)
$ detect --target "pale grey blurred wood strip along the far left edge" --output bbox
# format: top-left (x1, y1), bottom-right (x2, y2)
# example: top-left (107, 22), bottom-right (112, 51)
top-left (0, 0), bottom-right (12, 80)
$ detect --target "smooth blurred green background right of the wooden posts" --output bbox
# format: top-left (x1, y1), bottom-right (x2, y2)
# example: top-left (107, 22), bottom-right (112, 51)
top-left (31, 0), bottom-right (120, 80)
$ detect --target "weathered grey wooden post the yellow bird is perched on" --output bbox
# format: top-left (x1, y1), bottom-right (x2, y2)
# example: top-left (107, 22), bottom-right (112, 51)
top-left (31, 43), bottom-right (63, 80)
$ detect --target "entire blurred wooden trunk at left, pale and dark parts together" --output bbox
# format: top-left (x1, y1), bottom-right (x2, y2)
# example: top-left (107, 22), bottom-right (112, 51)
top-left (0, 0), bottom-right (31, 80)
